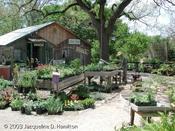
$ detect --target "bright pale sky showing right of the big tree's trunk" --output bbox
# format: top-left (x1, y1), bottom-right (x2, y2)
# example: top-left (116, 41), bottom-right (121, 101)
top-left (108, 0), bottom-right (173, 36)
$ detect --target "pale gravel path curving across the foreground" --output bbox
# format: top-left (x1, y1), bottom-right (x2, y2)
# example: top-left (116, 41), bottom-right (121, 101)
top-left (0, 93), bottom-right (138, 131)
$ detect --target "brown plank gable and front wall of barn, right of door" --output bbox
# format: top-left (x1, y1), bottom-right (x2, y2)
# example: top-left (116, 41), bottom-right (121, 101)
top-left (37, 23), bottom-right (91, 64)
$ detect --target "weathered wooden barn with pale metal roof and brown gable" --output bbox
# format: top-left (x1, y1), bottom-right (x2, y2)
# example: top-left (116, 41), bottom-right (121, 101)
top-left (0, 22), bottom-right (91, 64)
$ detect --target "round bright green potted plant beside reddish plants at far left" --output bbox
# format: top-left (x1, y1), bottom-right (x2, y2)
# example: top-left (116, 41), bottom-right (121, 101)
top-left (10, 98), bottom-right (23, 111)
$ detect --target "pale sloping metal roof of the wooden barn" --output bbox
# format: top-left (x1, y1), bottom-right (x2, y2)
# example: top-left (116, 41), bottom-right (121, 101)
top-left (0, 22), bottom-right (54, 46)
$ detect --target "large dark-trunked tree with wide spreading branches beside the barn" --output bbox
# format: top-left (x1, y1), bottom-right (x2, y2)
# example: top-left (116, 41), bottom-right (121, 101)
top-left (4, 0), bottom-right (175, 60)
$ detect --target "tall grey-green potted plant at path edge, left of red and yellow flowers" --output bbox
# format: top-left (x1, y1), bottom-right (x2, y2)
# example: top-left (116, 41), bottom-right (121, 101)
top-left (46, 97), bottom-right (63, 115)
